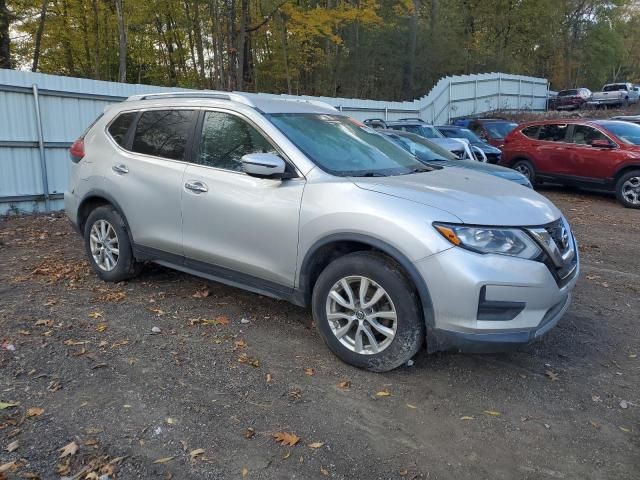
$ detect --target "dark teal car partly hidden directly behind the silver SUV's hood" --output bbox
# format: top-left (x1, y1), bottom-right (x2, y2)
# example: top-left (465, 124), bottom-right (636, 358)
top-left (380, 130), bottom-right (533, 188)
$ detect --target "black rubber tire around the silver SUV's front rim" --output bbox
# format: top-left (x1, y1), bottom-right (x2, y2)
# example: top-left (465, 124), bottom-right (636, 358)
top-left (312, 252), bottom-right (425, 372)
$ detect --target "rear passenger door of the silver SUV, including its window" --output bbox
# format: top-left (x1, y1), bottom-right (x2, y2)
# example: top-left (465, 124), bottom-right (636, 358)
top-left (105, 109), bottom-right (196, 255)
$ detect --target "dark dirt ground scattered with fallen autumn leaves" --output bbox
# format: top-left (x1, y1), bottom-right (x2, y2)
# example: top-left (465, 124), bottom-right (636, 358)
top-left (0, 188), bottom-right (640, 480)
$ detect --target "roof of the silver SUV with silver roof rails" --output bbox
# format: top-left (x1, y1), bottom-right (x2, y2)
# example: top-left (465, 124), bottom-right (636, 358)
top-left (125, 90), bottom-right (340, 114)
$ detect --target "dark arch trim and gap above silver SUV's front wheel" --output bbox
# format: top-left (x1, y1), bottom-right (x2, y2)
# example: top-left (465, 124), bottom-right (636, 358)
top-left (298, 233), bottom-right (435, 334)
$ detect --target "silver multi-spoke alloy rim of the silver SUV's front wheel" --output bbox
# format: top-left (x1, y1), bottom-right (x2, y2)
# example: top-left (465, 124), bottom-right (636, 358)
top-left (326, 276), bottom-right (398, 355)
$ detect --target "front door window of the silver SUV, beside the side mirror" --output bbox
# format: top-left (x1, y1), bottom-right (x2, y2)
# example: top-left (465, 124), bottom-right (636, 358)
top-left (197, 112), bottom-right (274, 172)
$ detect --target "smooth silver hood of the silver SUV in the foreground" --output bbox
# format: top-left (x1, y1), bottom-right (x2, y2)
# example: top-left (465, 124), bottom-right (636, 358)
top-left (351, 168), bottom-right (561, 226)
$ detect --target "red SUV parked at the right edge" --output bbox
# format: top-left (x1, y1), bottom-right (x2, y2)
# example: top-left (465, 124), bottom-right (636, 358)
top-left (500, 120), bottom-right (640, 208)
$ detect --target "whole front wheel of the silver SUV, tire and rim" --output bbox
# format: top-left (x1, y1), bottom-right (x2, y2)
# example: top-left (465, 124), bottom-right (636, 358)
top-left (312, 252), bottom-right (425, 372)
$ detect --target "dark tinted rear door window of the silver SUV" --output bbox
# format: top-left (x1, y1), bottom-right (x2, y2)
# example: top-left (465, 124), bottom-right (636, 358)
top-left (131, 110), bottom-right (194, 160)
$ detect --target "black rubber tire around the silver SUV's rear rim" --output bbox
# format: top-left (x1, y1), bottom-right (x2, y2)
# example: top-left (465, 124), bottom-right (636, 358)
top-left (84, 205), bottom-right (140, 282)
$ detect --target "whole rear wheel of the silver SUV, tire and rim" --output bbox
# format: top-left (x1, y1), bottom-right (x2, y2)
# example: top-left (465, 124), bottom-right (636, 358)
top-left (84, 205), bottom-right (140, 282)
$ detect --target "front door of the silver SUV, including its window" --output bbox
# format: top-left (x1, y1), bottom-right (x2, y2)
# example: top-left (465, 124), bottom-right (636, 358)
top-left (182, 110), bottom-right (305, 288)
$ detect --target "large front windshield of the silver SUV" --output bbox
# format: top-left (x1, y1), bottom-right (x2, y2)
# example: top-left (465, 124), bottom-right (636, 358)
top-left (268, 113), bottom-right (429, 177)
